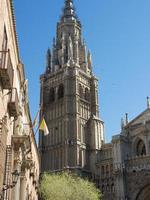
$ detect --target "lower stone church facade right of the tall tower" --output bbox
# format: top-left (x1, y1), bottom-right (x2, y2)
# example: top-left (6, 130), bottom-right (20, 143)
top-left (94, 106), bottom-right (150, 200)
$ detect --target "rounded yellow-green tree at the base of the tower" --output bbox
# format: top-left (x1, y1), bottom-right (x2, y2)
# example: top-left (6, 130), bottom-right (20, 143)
top-left (39, 173), bottom-right (101, 200)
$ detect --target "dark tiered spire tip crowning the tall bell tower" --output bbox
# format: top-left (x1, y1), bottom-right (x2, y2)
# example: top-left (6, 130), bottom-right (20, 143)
top-left (61, 0), bottom-right (78, 22)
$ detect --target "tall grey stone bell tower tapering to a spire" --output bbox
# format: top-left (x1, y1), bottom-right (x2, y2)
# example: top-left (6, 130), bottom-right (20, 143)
top-left (39, 0), bottom-right (104, 174)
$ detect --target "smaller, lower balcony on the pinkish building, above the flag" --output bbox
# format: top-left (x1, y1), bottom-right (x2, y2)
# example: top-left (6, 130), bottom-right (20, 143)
top-left (8, 88), bottom-right (19, 117)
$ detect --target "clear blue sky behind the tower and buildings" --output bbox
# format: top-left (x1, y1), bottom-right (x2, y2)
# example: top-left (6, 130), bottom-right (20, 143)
top-left (14, 0), bottom-right (150, 141)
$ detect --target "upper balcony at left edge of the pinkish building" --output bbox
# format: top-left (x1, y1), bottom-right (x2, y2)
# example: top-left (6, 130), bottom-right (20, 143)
top-left (0, 50), bottom-right (14, 89)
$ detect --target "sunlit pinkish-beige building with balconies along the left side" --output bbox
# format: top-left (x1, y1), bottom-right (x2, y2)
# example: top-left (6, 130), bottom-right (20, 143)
top-left (0, 0), bottom-right (39, 200)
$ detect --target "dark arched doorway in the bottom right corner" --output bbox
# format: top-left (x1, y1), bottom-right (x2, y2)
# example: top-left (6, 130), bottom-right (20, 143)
top-left (136, 185), bottom-right (150, 200)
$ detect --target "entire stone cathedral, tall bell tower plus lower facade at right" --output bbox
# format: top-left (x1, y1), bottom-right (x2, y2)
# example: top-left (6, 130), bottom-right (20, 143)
top-left (39, 0), bottom-right (150, 200)
